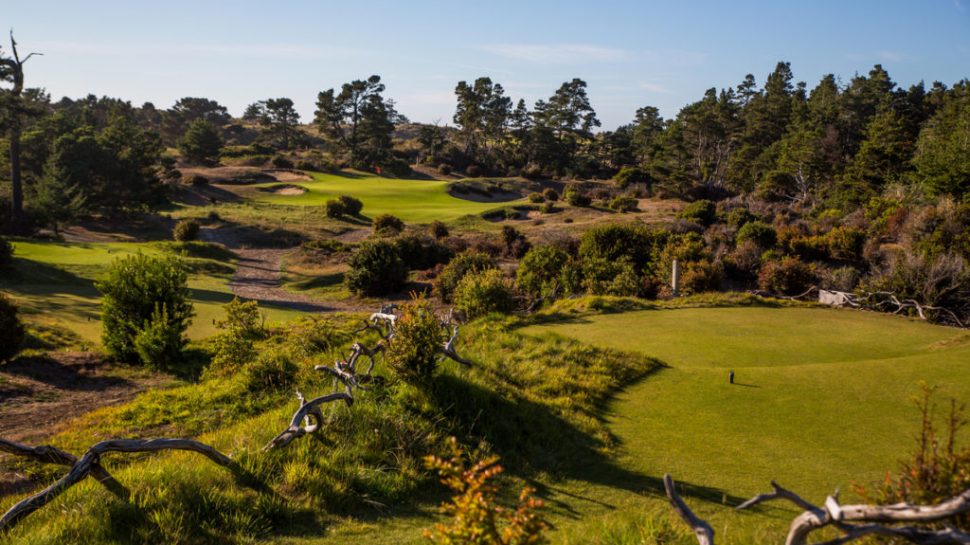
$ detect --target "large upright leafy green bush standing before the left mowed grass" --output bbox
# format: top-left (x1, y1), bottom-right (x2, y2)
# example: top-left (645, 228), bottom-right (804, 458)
top-left (95, 253), bottom-right (193, 363)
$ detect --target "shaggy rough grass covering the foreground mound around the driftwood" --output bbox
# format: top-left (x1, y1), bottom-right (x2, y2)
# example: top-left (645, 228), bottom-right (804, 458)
top-left (0, 312), bottom-right (657, 544)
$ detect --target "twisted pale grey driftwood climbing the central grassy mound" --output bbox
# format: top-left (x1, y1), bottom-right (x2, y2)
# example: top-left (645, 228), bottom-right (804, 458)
top-left (263, 305), bottom-right (471, 451)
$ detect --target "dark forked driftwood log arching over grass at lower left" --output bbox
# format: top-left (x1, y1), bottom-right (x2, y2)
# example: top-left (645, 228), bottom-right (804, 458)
top-left (0, 439), bottom-right (236, 532)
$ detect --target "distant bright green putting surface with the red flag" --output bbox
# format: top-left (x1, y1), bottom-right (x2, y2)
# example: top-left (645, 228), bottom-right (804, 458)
top-left (253, 173), bottom-right (520, 223)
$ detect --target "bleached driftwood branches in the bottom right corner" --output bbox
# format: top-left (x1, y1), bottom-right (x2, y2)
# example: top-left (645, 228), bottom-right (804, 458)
top-left (664, 475), bottom-right (970, 545)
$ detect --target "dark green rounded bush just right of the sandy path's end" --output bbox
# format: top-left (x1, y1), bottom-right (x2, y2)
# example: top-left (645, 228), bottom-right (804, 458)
top-left (345, 240), bottom-right (408, 295)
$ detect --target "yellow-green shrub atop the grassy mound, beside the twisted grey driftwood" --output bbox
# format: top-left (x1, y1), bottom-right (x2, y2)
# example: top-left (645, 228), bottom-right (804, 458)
top-left (384, 296), bottom-right (446, 382)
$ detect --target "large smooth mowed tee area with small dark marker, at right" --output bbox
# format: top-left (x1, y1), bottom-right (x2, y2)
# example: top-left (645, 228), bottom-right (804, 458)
top-left (526, 307), bottom-right (970, 499)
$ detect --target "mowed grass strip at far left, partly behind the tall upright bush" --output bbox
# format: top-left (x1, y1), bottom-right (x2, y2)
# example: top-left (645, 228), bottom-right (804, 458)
top-left (0, 242), bottom-right (298, 344)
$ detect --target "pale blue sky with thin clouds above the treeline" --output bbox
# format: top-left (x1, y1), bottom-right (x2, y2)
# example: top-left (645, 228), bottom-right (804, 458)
top-left (0, 0), bottom-right (970, 129)
